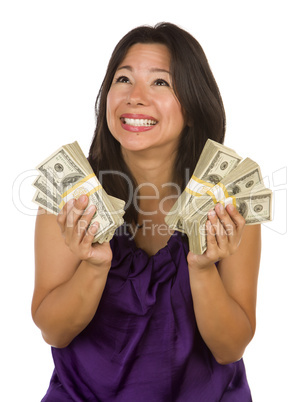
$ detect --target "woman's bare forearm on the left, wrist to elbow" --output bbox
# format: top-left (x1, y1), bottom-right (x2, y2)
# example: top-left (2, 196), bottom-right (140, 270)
top-left (33, 261), bottom-right (109, 348)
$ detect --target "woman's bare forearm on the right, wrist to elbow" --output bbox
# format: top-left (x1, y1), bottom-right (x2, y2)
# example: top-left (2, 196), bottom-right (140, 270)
top-left (189, 265), bottom-right (254, 364)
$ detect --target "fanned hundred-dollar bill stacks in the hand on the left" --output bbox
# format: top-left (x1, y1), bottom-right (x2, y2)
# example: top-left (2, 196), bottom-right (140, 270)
top-left (33, 142), bottom-right (125, 243)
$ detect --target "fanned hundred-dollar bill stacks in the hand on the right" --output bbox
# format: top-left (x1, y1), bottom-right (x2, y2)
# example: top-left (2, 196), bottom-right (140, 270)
top-left (165, 139), bottom-right (272, 254)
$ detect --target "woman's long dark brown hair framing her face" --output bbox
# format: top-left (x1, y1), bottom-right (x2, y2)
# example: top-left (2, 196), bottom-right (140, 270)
top-left (89, 23), bottom-right (226, 223)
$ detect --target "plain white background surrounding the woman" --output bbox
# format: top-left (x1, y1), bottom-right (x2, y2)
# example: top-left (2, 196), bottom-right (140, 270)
top-left (0, 0), bottom-right (298, 402)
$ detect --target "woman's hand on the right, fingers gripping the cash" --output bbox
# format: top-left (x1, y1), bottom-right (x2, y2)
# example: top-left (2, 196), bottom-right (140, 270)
top-left (187, 204), bottom-right (245, 269)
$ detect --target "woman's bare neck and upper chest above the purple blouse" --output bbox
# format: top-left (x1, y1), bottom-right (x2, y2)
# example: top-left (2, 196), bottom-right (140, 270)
top-left (122, 150), bottom-right (180, 255)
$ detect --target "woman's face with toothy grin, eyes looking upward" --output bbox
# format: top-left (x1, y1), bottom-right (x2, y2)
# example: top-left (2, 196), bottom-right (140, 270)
top-left (106, 43), bottom-right (185, 155)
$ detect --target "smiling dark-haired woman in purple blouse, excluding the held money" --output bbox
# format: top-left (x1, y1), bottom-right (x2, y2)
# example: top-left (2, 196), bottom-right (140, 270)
top-left (32, 23), bottom-right (260, 402)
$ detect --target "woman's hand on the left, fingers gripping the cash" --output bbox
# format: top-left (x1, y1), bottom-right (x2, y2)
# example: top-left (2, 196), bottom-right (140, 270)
top-left (57, 195), bottom-right (112, 267)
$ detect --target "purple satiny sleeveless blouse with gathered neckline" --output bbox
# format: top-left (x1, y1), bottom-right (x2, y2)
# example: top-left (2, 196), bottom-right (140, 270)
top-left (42, 227), bottom-right (252, 402)
